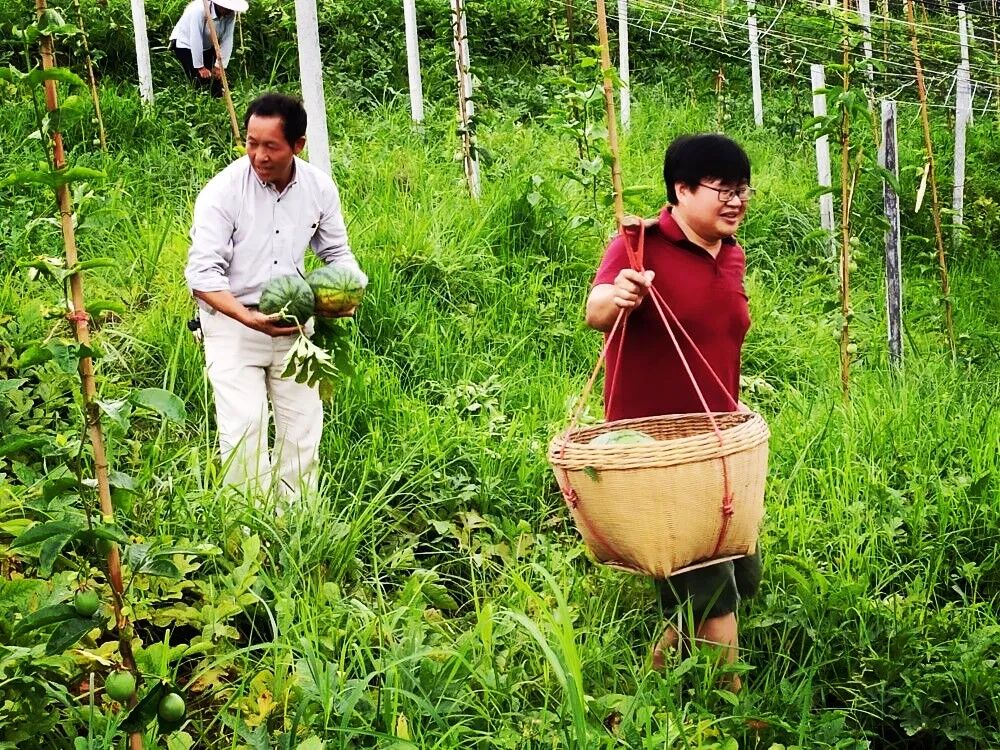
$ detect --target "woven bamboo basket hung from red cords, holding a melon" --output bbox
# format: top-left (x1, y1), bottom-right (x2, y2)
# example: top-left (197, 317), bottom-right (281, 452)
top-left (548, 412), bottom-right (770, 578)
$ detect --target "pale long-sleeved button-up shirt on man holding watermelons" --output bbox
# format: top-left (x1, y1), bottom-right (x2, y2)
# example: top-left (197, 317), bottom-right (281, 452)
top-left (184, 156), bottom-right (367, 305)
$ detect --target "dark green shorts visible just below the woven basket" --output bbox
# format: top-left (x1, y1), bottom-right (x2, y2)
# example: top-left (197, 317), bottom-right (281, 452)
top-left (656, 548), bottom-right (763, 622)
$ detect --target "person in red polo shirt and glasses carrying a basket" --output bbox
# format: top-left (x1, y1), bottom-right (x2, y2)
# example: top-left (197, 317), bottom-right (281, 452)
top-left (587, 134), bottom-right (761, 689)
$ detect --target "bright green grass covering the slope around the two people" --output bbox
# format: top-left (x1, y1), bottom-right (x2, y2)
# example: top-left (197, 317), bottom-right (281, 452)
top-left (0, 78), bottom-right (1000, 750)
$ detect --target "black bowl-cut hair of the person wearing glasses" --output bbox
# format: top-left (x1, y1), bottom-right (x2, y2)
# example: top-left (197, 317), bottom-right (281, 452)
top-left (663, 133), bottom-right (750, 206)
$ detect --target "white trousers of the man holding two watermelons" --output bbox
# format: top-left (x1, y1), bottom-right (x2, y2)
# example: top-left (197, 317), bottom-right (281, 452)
top-left (201, 311), bottom-right (323, 498)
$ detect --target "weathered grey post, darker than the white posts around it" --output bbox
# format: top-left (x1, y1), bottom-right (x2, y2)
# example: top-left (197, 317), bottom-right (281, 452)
top-left (879, 100), bottom-right (903, 367)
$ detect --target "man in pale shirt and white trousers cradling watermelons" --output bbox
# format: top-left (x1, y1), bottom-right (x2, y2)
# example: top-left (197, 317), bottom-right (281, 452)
top-left (184, 93), bottom-right (367, 506)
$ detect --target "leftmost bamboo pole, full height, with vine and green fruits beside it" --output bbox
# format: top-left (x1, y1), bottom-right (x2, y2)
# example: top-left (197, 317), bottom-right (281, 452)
top-left (35, 0), bottom-right (142, 750)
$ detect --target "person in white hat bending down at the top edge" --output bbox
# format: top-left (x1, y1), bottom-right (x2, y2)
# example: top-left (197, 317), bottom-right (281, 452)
top-left (170, 0), bottom-right (248, 98)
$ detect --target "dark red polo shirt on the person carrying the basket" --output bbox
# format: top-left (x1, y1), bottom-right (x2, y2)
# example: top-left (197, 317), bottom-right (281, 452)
top-left (594, 207), bottom-right (750, 420)
